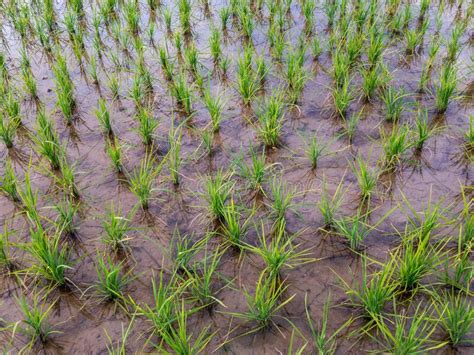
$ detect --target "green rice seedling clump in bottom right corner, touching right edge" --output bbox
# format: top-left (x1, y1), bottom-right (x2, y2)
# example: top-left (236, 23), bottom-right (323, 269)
top-left (434, 293), bottom-right (474, 347)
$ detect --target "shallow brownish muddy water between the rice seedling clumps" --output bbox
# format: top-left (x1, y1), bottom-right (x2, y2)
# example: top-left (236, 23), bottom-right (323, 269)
top-left (0, 1), bottom-right (474, 354)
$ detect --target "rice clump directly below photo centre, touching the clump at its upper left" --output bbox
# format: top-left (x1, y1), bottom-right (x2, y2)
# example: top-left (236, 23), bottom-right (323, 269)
top-left (221, 198), bottom-right (251, 249)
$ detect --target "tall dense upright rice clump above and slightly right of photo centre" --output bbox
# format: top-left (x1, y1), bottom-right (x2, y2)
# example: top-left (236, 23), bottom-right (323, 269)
top-left (257, 93), bottom-right (285, 148)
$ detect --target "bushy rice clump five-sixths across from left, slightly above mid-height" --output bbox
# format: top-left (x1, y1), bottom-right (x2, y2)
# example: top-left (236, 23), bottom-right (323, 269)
top-left (380, 125), bottom-right (411, 168)
